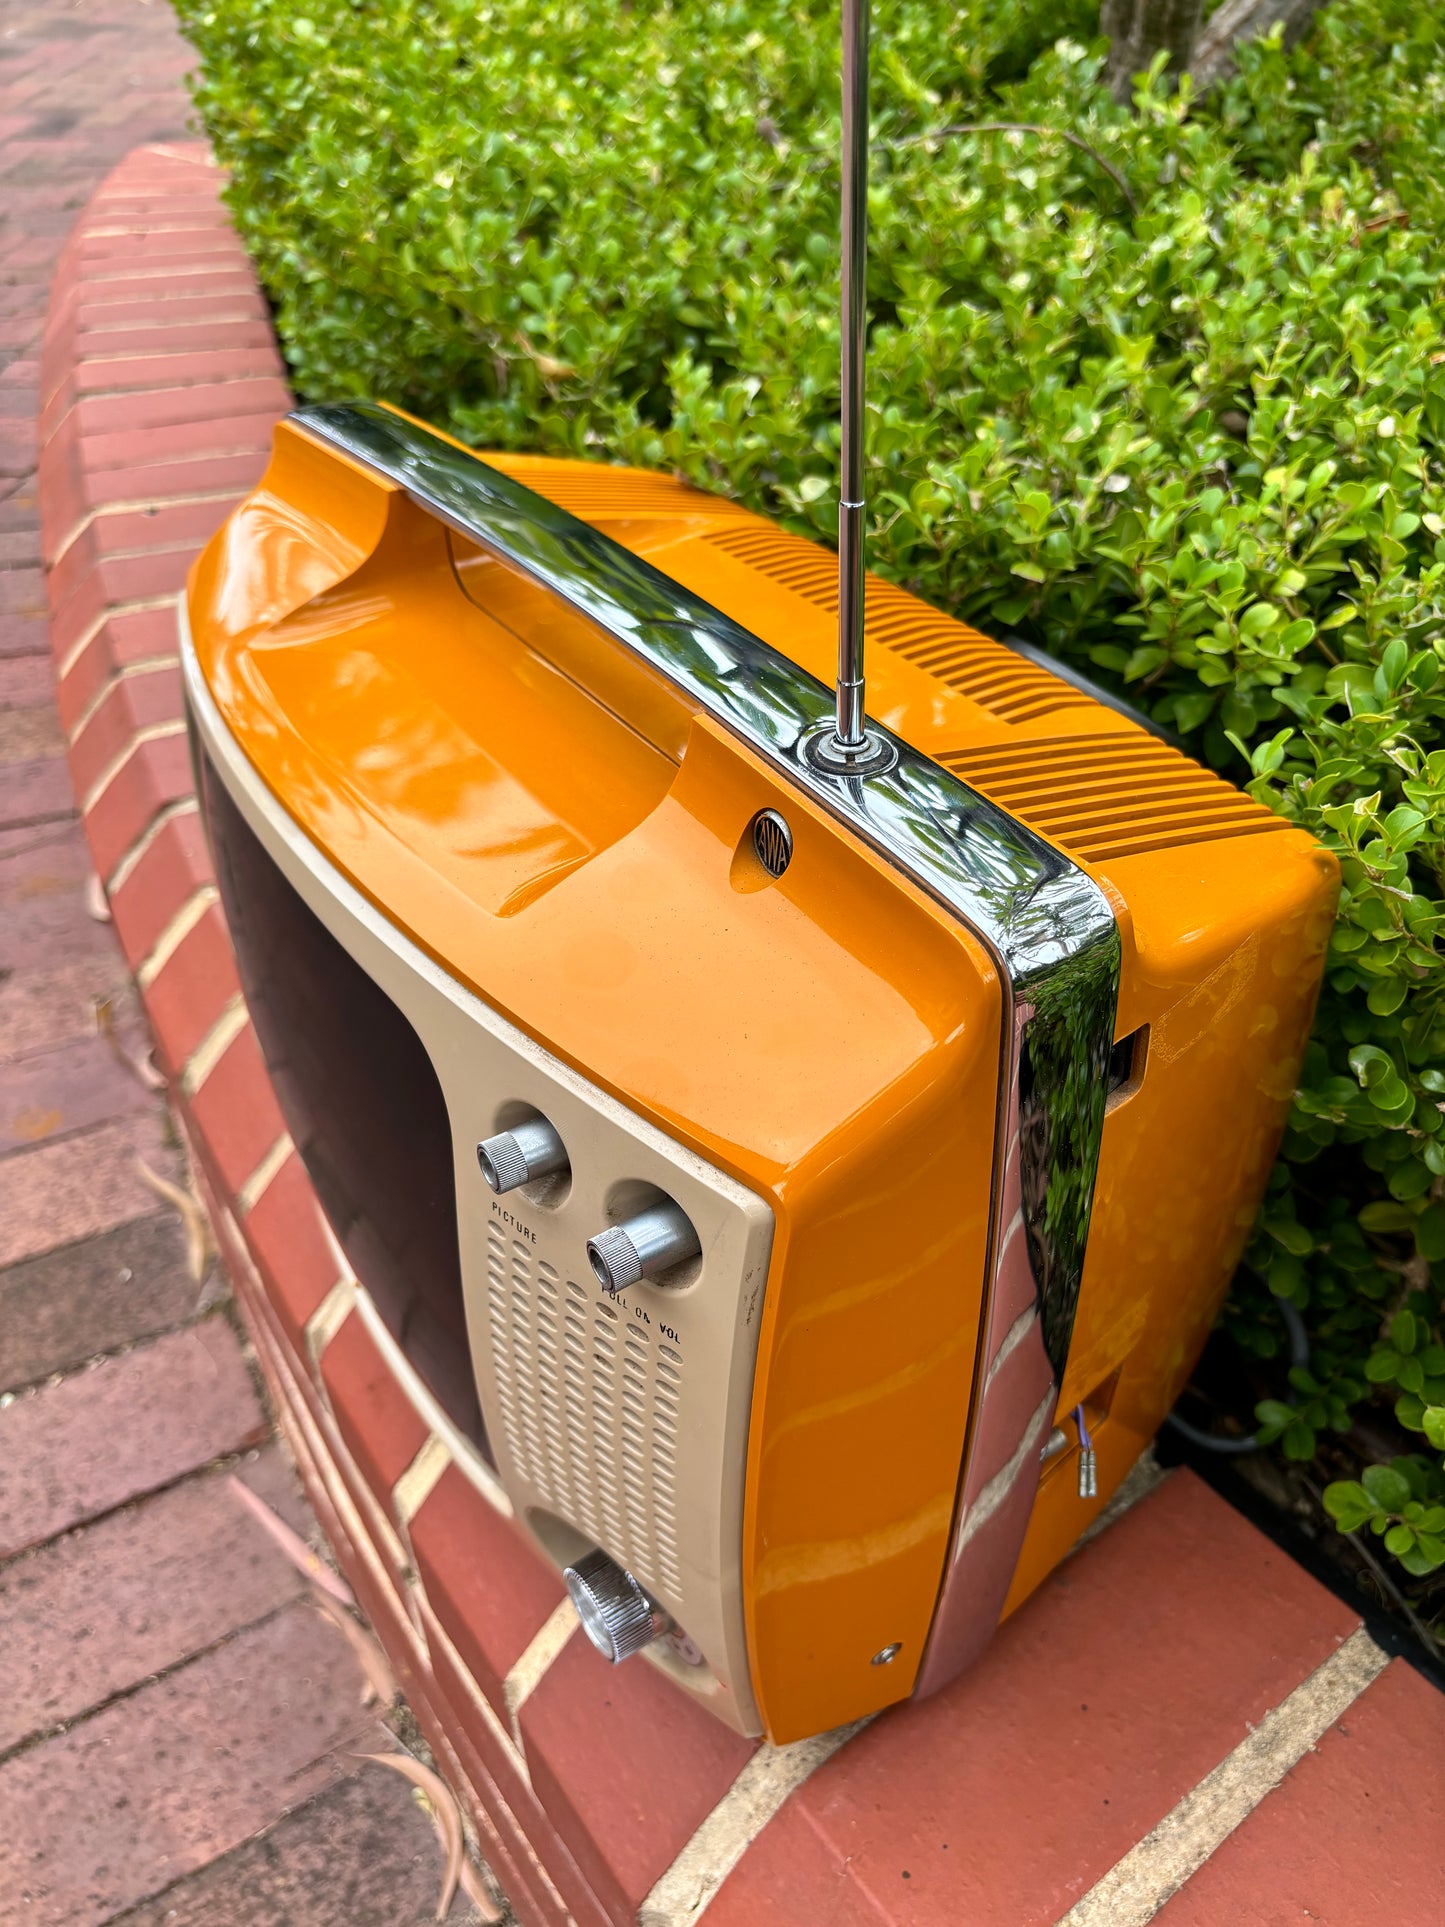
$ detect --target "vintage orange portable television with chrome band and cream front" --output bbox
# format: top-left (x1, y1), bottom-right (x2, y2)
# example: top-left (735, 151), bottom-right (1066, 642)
top-left (183, 7), bottom-right (1337, 1742)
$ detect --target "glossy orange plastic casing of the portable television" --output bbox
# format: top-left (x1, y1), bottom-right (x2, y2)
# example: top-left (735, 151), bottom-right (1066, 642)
top-left (189, 424), bottom-right (1337, 1742)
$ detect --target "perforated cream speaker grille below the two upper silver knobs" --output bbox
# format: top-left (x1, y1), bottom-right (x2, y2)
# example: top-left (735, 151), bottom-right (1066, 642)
top-left (487, 1224), bottom-right (682, 1601)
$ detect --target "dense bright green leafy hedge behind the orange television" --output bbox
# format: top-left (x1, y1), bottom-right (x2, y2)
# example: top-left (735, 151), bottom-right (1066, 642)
top-left (181, 0), bottom-right (1445, 1596)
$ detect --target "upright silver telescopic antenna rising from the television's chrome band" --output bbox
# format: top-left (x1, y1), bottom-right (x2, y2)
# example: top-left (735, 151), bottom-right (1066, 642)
top-left (807, 0), bottom-right (894, 777)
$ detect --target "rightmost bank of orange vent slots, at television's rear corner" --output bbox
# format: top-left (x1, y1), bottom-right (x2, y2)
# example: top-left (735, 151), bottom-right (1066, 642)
top-left (938, 730), bottom-right (1289, 863)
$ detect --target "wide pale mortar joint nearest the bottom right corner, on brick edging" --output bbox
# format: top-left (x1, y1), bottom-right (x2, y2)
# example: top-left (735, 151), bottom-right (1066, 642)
top-left (1056, 1628), bottom-right (1389, 1927)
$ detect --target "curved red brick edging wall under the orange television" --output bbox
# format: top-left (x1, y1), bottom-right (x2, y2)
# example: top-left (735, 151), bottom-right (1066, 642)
top-left (40, 145), bottom-right (1445, 1927)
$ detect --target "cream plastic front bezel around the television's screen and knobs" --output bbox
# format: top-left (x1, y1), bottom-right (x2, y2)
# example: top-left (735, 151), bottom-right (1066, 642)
top-left (192, 603), bottom-right (786, 1736)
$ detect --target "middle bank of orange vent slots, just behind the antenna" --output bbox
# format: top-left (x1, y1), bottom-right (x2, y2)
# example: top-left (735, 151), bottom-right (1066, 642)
top-left (707, 520), bottom-right (1092, 723)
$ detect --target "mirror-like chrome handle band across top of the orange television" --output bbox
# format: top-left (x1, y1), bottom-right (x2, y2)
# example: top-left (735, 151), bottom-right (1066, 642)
top-left (291, 403), bottom-right (1119, 1374)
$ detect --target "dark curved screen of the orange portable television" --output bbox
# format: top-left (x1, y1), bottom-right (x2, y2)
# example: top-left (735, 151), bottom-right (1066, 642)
top-left (198, 753), bottom-right (491, 1459)
